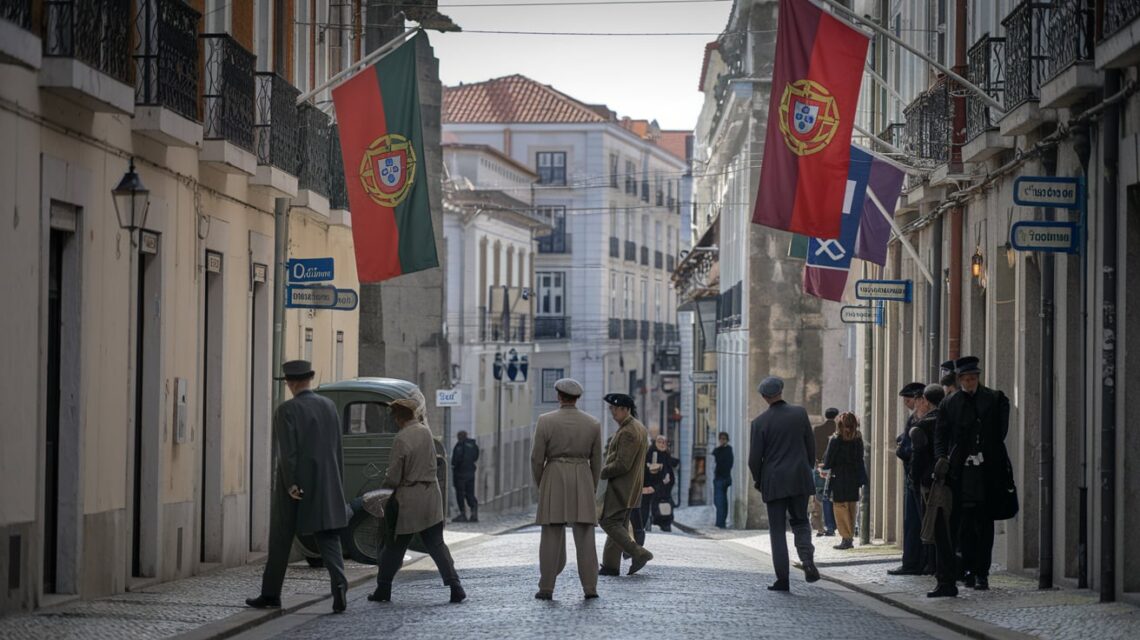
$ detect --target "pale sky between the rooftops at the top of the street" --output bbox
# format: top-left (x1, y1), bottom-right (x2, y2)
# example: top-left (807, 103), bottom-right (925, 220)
top-left (429, 0), bottom-right (732, 130)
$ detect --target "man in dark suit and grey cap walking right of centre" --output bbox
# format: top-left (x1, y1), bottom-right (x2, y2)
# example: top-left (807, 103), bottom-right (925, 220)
top-left (748, 376), bottom-right (820, 591)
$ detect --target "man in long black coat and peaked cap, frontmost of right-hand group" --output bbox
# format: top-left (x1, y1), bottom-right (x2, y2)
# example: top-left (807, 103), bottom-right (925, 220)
top-left (927, 356), bottom-right (1017, 598)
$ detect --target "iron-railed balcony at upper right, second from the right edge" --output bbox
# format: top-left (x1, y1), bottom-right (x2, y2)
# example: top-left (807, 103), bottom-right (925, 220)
top-left (1041, 0), bottom-right (1099, 108)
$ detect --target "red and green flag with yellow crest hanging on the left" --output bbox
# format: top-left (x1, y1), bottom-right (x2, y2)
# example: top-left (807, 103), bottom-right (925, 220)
top-left (333, 33), bottom-right (439, 283)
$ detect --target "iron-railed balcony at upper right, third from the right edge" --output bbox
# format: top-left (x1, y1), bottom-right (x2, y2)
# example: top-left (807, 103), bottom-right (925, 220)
top-left (1000, 0), bottom-right (1051, 136)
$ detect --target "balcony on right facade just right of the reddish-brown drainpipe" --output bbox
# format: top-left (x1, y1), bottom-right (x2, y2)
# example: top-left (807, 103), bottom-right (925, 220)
top-left (962, 35), bottom-right (1011, 162)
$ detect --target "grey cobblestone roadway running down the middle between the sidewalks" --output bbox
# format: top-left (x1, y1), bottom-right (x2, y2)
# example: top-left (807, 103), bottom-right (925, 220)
top-left (239, 527), bottom-right (958, 640)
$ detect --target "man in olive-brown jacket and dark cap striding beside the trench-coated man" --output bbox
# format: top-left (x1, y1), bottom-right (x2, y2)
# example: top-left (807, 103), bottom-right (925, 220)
top-left (599, 394), bottom-right (653, 576)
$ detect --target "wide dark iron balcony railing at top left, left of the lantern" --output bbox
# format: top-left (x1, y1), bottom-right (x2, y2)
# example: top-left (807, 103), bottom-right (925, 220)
top-left (43, 0), bottom-right (131, 84)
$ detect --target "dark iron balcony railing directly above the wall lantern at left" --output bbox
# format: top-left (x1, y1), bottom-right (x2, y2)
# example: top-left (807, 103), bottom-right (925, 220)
top-left (135, 0), bottom-right (202, 120)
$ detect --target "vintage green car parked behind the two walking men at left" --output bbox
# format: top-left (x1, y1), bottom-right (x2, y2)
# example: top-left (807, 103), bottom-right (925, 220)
top-left (296, 378), bottom-right (447, 566)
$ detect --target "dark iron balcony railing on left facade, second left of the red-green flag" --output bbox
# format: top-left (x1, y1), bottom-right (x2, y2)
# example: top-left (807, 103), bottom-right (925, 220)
top-left (202, 33), bottom-right (254, 152)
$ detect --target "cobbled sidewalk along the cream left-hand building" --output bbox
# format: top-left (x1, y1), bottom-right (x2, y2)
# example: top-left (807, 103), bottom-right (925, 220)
top-left (0, 509), bottom-right (535, 640)
